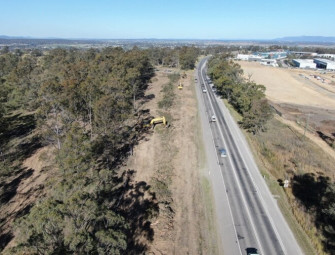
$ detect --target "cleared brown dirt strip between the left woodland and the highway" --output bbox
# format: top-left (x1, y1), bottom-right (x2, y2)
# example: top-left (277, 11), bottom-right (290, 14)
top-left (127, 68), bottom-right (213, 254)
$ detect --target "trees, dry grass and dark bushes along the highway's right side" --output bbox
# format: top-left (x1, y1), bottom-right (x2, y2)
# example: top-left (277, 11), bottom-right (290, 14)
top-left (209, 52), bottom-right (335, 254)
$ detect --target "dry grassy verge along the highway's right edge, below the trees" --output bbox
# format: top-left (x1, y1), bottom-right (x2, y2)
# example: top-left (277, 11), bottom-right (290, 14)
top-left (224, 100), bottom-right (322, 254)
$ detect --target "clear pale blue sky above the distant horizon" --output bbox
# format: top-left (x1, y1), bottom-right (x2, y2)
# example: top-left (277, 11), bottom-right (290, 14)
top-left (0, 0), bottom-right (335, 39)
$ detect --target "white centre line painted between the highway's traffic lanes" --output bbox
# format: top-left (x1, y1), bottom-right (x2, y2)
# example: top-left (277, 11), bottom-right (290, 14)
top-left (200, 61), bottom-right (264, 254)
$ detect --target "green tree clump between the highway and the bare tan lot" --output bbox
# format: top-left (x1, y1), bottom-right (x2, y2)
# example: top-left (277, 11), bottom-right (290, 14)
top-left (208, 54), bottom-right (272, 134)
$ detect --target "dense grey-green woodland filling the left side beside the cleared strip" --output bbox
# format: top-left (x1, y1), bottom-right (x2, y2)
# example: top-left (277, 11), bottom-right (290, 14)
top-left (0, 48), bottom-right (157, 254)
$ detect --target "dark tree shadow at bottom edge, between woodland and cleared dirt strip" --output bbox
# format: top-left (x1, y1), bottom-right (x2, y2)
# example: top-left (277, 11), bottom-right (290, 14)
top-left (115, 170), bottom-right (159, 254)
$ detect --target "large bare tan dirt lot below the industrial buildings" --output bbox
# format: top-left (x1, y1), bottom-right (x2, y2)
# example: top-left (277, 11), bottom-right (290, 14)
top-left (238, 61), bottom-right (335, 158)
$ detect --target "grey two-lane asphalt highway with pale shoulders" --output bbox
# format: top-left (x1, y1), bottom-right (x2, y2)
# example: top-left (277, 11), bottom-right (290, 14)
top-left (196, 58), bottom-right (303, 255)
